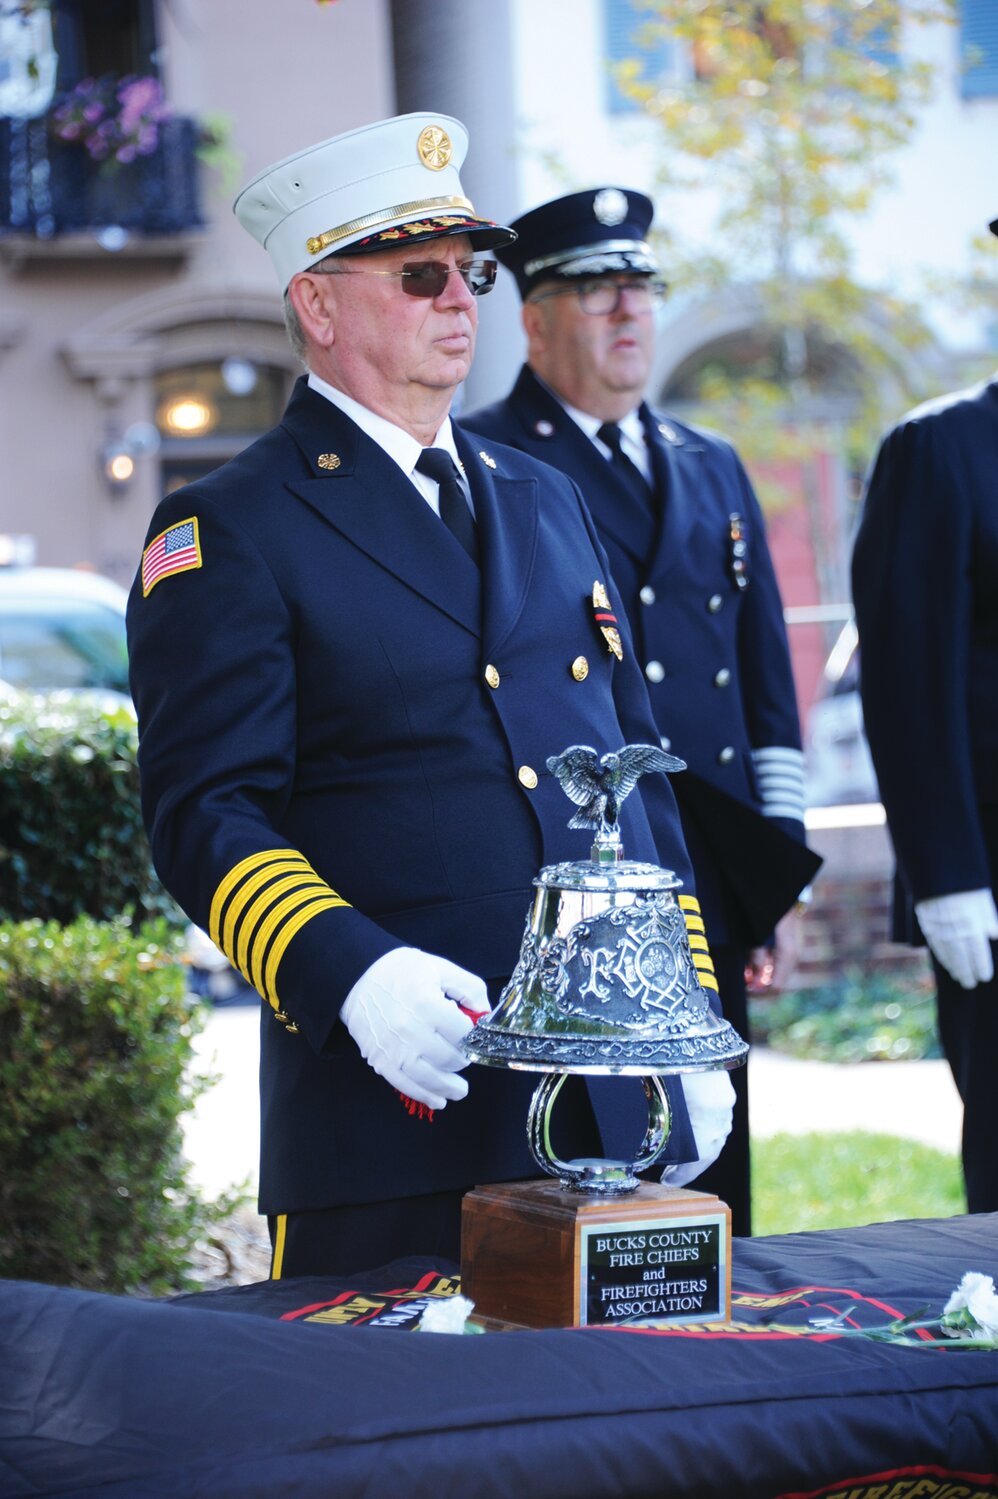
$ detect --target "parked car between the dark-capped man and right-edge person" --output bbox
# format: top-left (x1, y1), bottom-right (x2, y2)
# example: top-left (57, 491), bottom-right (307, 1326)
top-left (805, 619), bottom-right (880, 806)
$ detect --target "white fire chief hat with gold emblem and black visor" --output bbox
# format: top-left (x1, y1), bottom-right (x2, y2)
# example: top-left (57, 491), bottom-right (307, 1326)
top-left (232, 114), bottom-right (515, 291)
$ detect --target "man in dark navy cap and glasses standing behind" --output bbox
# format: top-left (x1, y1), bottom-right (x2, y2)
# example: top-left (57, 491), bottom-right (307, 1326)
top-left (463, 187), bottom-right (818, 1234)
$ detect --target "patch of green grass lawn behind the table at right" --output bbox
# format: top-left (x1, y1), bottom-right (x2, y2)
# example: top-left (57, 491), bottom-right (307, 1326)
top-left (752, 1132), bottom-right (967, 1235)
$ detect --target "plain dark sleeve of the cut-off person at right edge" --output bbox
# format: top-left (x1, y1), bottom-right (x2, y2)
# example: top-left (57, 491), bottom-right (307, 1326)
top-left (853, 408), bottom-right (991, 901)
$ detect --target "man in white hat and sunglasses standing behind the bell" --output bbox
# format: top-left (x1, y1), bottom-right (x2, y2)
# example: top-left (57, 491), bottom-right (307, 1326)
top-left (129, 114), bottom-right (731, 1276)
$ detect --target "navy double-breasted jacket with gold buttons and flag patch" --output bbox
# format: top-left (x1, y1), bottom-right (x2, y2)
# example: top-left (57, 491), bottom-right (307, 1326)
top-left (129, 381), bottom-right (710, 1213)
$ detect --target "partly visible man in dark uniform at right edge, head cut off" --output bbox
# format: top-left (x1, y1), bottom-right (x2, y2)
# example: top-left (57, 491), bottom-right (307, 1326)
top-left (853, 219), bottom-right (998, 1213)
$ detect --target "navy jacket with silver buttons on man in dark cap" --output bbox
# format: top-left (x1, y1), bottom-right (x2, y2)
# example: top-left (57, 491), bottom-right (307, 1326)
top-left (463, 367), bottom-right (803, 946)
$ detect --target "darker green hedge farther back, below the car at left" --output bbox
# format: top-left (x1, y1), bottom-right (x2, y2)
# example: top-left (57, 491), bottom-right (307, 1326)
top-left (0, 694), bottom-right (178, 922)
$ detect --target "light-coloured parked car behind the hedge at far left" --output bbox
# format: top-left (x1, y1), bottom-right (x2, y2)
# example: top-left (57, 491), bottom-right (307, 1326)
top-left (0, 567), bottom-right (130, 706)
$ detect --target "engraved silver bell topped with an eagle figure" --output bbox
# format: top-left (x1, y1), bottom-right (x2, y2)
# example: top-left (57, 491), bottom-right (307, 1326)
top-left (463, 745), bottom-right (748, 1193)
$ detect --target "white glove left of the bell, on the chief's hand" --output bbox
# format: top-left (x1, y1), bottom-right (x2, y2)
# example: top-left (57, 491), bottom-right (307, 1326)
top-left (340, 947), bottom-right (489, 1109)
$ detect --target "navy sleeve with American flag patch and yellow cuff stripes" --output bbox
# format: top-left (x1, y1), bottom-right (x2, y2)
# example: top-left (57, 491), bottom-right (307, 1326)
top-left (127, 490), bottom-right (399, 1051)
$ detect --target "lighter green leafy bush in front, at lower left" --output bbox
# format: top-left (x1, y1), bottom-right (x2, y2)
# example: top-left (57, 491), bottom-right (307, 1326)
top-left (0, 917), bottom-right (232, 1294)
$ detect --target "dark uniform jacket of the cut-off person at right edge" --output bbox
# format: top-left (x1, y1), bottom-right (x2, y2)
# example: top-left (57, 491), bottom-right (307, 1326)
top-left (853, 381), bottom-right (998, 911)
